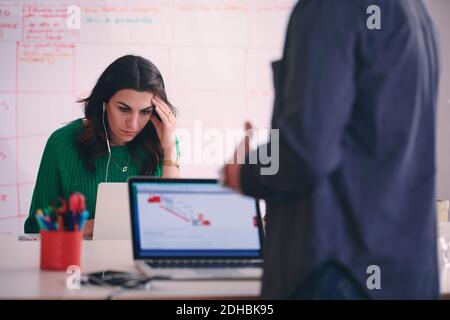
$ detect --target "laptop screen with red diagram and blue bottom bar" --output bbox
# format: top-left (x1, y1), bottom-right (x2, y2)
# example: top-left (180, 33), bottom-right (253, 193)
top-left (129, 179), bottom-right (261, 259)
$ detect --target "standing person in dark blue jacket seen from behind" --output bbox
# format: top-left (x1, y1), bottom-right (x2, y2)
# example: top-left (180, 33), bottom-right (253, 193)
top-left (241, 0), bottom-right (439, 299)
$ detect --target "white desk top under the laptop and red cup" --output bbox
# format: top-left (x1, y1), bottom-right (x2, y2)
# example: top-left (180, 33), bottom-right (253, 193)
top-left (0, 235), bottom-right (260, 299)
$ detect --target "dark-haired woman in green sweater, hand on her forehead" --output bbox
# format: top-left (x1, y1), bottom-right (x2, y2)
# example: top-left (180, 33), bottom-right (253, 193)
top-left (25, 55), bottom-right (179, 236)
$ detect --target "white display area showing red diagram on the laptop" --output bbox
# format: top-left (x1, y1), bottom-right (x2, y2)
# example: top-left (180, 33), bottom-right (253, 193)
top-left (137, 192), bottom-right (259, 250)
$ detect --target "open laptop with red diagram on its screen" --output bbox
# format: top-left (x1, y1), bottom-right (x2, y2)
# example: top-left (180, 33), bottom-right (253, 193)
top-left (128, 177), bottom-right (263, 280)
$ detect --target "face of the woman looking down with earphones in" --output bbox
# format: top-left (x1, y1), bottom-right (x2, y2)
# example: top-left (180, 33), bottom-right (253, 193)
top-left (106, 89), bottom-right (153, 146)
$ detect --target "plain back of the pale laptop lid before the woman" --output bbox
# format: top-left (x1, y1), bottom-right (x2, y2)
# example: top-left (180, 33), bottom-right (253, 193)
top-left (92, 182), bottom-right (131, 240)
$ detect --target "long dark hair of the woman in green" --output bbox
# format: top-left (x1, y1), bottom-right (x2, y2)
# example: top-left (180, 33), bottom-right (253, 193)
top-left (76, 55), bottom-right (177, 175)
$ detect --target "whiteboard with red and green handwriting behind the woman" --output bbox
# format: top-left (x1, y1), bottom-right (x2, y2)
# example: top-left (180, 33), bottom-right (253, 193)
top-left (0, 0), bottom-right (295, 233)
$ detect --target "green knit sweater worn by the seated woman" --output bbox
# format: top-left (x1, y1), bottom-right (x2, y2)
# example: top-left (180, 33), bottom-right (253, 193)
top-left (24, 119), bottom-right (179, 233)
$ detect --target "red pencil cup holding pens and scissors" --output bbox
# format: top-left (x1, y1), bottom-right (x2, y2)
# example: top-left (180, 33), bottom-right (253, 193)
top-left (41, 230), bottom-right (83, 271)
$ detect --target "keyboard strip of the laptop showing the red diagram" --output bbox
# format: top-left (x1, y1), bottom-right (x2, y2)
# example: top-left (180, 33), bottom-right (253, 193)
top-left (146, 259), bottom-right (262, 268)
